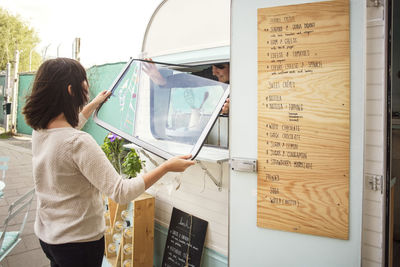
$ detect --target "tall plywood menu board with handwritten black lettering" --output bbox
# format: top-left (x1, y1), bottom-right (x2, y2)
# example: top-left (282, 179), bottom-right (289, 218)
top-left (257, 0), bottom-right (350, 239)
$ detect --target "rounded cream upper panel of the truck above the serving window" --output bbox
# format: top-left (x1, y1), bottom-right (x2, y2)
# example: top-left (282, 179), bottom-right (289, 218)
top-left (142, 0), bottom-right (230, 57)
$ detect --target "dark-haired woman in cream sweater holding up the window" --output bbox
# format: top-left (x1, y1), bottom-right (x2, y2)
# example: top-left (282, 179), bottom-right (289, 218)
top-left (23, 58), bottom-right (194, 267)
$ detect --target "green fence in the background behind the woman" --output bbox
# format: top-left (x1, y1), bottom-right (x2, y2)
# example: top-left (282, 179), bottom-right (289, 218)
top-left (16, 62), bottom-right (126, 144)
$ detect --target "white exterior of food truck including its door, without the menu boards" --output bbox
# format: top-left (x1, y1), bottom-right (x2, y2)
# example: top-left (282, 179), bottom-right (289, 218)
top-left (136, 0), bottom-right (396, 267)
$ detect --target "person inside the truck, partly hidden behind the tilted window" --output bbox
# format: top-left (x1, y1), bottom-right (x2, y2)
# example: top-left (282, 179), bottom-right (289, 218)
top-left (143, 59), bottom-right (230, 115)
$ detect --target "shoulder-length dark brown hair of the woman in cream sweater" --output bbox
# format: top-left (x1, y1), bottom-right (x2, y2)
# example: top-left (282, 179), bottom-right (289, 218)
top-left (22, 58), bottom-right (88, 130)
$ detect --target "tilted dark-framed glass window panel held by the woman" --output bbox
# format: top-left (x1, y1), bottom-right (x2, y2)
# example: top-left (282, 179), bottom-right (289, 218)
top-left (95, 60), bottom-right (229, 158)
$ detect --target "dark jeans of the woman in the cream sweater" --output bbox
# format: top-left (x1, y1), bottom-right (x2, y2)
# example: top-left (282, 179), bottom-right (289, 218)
top-left (39, 237), bottom-right (104, 267)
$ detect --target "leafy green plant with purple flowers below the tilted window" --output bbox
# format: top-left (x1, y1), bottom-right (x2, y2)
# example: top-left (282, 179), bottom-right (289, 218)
top-left (101, 133), bottom-right (144, 179)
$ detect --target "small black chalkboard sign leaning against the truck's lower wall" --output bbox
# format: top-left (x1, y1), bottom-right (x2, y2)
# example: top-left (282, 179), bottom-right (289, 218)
top-left (162, 208), bottom-right (208, 267)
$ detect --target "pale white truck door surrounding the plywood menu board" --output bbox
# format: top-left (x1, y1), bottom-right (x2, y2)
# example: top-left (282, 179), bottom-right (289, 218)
top-left (229, 0), bottom-right (366, 267)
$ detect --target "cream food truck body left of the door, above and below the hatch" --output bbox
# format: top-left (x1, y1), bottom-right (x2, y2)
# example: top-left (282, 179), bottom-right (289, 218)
top-left (142, 0), bottom-right (231, 266)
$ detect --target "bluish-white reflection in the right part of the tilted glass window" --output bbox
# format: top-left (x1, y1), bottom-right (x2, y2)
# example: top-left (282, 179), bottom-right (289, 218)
top-left (149, 63), bottom-right (227, 145)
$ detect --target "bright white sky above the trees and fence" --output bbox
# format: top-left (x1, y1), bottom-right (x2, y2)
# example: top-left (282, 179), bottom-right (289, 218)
top-left (0, 0), bottom-right (162, 68)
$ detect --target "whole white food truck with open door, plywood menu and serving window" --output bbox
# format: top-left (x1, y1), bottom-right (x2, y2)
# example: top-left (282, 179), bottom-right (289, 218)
top-left (95, 0), bottom-right (400, 267)
